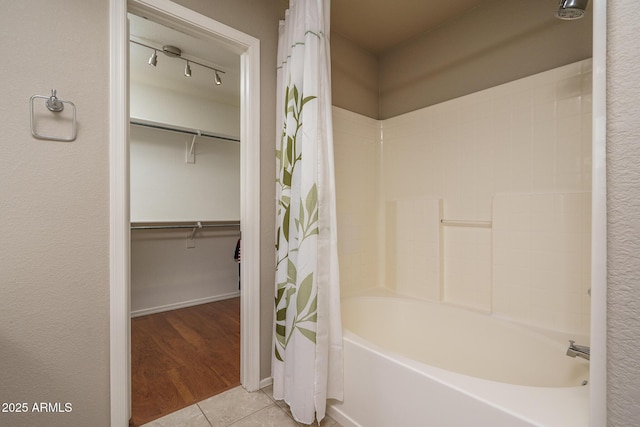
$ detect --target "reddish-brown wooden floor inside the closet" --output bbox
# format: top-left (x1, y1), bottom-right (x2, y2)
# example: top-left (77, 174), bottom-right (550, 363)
top-left (130, 298), bottom-right (240, 426)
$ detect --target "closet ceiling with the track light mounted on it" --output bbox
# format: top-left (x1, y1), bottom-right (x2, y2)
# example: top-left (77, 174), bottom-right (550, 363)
top-left (129, 14), bottom-right (240, 105)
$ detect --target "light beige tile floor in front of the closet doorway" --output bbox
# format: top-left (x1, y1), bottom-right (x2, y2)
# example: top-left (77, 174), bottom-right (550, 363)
top-left (142, 386), bottom-right (341, 427)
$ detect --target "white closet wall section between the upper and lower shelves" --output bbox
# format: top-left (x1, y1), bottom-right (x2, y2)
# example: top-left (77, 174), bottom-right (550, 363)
top-left (130, 126), bottom-right (240, 222)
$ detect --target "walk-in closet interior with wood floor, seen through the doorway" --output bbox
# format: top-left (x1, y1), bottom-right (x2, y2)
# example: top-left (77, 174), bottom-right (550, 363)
top-left (129, 14), bottom-right (240, 424)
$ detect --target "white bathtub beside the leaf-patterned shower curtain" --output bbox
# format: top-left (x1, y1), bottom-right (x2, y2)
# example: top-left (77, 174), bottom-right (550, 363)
top-left (328, 296), bottom-right (589, 427)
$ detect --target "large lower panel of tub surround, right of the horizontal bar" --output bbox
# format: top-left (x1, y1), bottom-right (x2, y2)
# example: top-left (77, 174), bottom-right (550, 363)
top-left (491, 192), bottom-right (591, 335)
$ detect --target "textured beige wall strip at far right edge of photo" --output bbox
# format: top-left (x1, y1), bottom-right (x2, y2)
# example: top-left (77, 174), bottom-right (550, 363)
top-left (607, 0), bottom-right (640, 427)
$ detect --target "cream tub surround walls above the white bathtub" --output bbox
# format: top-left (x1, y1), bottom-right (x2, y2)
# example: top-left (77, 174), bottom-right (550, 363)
top-left (334, 59), bottom-right (591, 333)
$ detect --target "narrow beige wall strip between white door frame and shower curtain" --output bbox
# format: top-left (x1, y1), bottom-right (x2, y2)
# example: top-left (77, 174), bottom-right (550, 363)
top-left (176, 0), bottom-right (280, 378)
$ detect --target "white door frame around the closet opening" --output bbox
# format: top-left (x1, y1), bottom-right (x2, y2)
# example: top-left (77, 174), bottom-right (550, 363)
top-left (109, 0), bottom-right (260, 427)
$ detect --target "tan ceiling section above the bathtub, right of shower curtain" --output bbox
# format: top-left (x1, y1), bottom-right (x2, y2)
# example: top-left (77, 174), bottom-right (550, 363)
top-left (328, 0), bottom-right (492, 54)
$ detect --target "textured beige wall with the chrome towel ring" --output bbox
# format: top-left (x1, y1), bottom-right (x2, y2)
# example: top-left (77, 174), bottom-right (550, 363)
top-left (0, 0), bottom-right (109, 427)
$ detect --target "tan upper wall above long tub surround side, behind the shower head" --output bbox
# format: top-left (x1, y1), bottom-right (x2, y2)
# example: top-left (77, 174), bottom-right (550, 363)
top-left (378, 0), bottom-right (592, 119)
